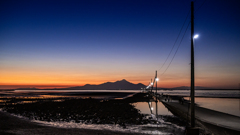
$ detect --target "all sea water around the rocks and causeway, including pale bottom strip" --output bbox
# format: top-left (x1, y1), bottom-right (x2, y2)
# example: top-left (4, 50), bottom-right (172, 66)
top-left (0, 90), bottom-right (240, 134)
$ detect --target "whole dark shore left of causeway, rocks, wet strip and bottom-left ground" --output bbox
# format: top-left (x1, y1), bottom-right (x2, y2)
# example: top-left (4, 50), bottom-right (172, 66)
top-left (0, 93), bottom-right (188, 135)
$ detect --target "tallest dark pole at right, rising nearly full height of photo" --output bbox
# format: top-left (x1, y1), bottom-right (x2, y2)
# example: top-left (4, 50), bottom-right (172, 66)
top-left (191, 1), bottom-right (195, 128)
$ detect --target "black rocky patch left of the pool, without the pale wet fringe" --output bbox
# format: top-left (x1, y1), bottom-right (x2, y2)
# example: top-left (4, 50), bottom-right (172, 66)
top-left (2, 93), bottom-right (154, 128)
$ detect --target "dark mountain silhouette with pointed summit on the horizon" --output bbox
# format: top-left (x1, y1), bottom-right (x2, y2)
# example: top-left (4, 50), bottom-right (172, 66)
top-left (67, 79), bottom-right (146, 90)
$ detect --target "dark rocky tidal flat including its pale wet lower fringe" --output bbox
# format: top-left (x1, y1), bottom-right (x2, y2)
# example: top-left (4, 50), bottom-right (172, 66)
top-left (1, 93), bottom-right (186, 134)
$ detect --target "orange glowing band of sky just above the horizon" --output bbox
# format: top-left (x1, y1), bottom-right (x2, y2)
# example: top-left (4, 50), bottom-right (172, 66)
top-left (0, 67), bottom-right (238, 89)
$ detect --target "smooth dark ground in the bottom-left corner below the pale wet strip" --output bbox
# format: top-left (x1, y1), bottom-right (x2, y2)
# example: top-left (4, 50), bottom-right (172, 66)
top-left (0, 111), bottom-right (147, 135)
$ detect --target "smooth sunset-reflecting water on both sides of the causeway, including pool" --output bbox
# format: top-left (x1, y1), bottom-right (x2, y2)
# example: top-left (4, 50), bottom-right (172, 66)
top-left (0, 90), bottom-right (240, 117)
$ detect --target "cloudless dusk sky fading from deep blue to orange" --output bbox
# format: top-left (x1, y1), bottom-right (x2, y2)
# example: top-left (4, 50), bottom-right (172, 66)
top-left (0, 0), bottom-right (240, 89)
